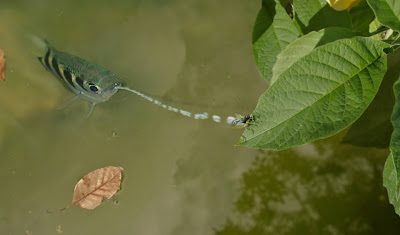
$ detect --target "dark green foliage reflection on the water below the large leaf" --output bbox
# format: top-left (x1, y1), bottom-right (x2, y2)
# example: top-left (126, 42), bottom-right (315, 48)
top-left (215, 136), bottom-right (400, 234)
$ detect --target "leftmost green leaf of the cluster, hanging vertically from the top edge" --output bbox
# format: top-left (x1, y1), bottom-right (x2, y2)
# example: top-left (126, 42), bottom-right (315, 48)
top-left (253, 0), bottom-right (299, 82)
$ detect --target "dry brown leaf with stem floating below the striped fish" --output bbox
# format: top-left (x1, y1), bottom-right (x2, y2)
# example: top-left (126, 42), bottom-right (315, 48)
top-left (49, 166), bottom-right (123, 213)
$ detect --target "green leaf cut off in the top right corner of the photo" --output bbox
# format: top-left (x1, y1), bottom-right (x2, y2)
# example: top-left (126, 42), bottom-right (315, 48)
top-left (368, 0), bottom-right (400, 31)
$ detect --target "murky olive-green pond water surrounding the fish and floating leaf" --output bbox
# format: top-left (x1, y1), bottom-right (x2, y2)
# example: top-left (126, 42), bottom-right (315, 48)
top-left (0, 0), bottom-right (400, 235)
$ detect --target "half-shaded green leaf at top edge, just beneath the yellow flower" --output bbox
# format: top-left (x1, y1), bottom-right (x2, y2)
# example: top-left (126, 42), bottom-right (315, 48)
top-left (293, 0), bottom-right (352, 34)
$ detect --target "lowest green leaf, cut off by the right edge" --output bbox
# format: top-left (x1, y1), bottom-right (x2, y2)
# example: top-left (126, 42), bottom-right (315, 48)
top-left (383, 154), bottom-right (400, 215)
